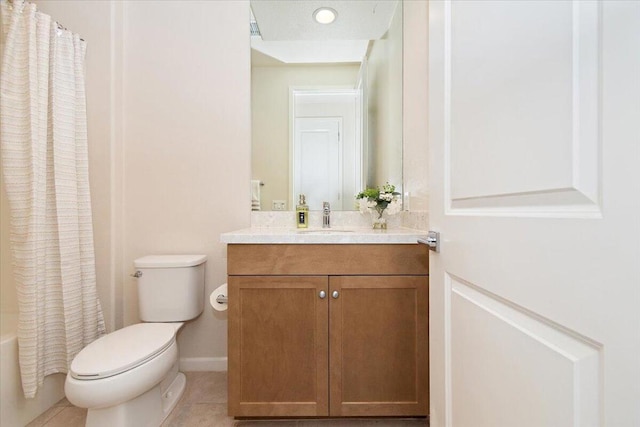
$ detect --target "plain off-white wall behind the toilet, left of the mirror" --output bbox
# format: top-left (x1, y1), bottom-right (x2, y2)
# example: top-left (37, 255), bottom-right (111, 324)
top-left (122, 1), bottom-right (251, 366)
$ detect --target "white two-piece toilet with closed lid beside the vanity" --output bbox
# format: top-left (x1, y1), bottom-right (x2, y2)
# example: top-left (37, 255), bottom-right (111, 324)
top-left (64, 255), bottom-right (207, 427)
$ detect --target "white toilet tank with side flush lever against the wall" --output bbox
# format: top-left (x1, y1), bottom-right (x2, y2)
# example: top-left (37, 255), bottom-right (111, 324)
top-left (133, 255), bottom-right (207, 322)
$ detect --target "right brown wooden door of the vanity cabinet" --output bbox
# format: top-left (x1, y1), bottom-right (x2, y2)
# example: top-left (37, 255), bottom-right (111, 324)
top-left (329, 276), bottom-right (429, 416)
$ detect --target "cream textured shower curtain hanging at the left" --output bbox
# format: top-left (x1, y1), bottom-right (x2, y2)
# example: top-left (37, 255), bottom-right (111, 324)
top-left (0, 0), bottom-right (105, 397)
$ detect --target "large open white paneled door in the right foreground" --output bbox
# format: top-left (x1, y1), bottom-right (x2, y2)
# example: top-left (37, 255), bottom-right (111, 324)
top-left (429, 1), bottom-right (640, 427)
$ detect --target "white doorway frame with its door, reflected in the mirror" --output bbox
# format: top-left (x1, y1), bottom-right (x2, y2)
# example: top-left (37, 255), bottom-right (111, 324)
top-left (289, 85), bottom-right (366, 210)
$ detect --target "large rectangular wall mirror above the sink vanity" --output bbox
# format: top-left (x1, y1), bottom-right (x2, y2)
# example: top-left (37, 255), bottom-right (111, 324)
top-left (251, 0), bottom-right (403, 211)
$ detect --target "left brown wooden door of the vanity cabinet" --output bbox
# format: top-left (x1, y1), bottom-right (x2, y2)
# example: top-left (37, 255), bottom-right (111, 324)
top-left (228, 276), bottom-right (329, 417)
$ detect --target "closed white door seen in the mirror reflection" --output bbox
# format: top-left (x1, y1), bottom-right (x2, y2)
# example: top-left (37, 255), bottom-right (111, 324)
top-left (293, 117), bottom-right (342, 210)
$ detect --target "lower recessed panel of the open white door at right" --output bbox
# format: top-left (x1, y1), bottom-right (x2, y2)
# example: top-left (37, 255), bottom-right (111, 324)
top-left (444, 275), bottom-right (602, 427)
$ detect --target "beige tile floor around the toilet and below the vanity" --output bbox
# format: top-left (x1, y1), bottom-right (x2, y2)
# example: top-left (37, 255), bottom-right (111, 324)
top-left (27, 372), bottom-right (429, 427)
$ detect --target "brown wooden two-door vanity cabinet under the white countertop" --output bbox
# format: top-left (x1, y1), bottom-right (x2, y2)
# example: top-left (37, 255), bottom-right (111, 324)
top-left (228, 244), bottom-right (429, 417)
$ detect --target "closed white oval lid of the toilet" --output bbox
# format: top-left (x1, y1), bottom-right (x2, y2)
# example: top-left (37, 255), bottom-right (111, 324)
top-left (71, 323), bottom-right (176, 380)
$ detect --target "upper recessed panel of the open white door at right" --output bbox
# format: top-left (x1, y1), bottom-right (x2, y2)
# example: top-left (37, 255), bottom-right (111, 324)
top-left (444, 1), bottom-right (601, 216)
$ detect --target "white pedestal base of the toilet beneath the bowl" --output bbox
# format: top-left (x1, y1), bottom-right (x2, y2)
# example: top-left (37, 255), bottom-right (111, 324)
top-left (85, 369), bottom-right (187, 427)
